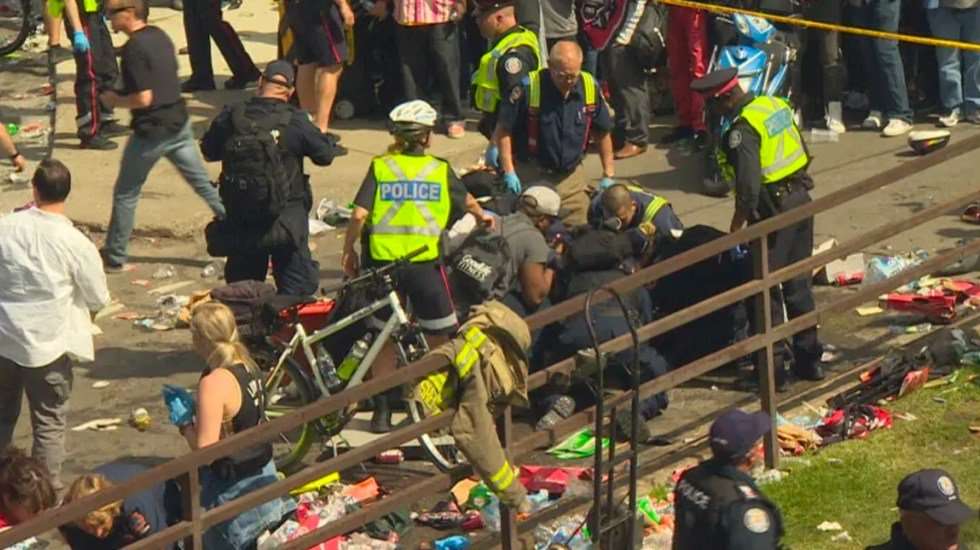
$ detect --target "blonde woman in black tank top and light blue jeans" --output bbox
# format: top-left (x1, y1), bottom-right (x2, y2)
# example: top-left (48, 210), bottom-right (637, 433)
top-left (181, 302), bottom-right (295, 550)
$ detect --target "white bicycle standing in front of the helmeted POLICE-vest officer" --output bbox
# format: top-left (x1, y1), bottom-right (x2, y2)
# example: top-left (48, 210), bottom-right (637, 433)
top-left (263, 247), bottom-right (463, 471)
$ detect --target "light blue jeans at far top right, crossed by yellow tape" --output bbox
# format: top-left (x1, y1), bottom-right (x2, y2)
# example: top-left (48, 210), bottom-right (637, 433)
top-left (926, 8), bottom-right (980, 113)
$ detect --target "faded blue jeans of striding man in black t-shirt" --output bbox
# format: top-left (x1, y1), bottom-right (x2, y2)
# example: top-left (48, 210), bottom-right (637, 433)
top-left (104, 120), bottom-right (225, 264)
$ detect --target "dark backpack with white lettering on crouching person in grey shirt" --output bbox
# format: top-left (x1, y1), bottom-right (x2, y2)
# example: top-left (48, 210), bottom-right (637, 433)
top-left (446, 228), bottom-right (517, 312)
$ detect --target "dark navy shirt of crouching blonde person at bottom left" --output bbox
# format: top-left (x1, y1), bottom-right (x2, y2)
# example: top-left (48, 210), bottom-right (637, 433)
top-left (61, 462), bottom-right (181, 550)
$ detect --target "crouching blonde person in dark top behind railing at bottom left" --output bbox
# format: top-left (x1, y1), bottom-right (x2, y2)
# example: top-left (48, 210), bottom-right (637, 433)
top-left (60, 462), bottom-right (182, 550)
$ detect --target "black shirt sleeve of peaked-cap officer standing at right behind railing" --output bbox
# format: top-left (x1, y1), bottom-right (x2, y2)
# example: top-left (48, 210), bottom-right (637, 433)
top-left (722, 94), bottom-right (762, 220)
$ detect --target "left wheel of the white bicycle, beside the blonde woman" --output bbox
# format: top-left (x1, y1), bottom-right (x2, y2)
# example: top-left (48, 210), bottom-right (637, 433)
top-left (263, 357), bottom-right (318, 470)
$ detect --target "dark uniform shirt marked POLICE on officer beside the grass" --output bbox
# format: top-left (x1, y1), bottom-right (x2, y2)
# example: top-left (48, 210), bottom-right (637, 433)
top-left (673, 459), bottom-right (783, 550)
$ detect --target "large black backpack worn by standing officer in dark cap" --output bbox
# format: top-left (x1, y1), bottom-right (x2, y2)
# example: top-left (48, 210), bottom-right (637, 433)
top-left (219, 103), bottom-right (293, 222)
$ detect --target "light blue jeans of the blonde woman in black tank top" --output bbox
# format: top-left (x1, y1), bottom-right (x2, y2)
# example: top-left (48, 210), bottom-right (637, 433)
top-left (200, 460), bottom-right (296, 550)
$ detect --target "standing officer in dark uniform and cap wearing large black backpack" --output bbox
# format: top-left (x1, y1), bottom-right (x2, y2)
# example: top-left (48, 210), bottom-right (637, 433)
top-left (201, 61), bottom-right (336, 296)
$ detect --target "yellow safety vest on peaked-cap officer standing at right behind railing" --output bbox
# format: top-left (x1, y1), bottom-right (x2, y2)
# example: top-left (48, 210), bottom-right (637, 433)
top-left (732, 96), bottom-right (810, 184)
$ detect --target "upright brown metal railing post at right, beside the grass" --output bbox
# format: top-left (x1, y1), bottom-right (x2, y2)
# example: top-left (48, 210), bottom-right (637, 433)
top-left (752, 235), bottom-right (782, 468)
